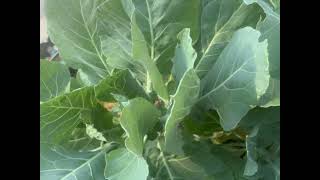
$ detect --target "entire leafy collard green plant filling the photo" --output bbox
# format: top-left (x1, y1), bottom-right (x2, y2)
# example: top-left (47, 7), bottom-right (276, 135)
top-left (40, 0), bottom-right (280, 180)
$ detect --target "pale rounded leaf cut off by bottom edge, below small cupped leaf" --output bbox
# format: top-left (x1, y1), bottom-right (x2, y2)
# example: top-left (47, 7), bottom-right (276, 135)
top-left (104, 148), bottom-right (149, 180)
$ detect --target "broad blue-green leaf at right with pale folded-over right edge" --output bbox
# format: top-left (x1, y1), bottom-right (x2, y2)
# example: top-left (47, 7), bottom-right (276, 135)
top-left (200, 27), bottom-right (270, 131)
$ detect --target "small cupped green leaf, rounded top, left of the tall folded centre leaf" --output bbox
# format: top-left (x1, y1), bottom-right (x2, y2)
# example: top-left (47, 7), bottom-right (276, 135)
top-left (120, 98), bottom-right (160, 156)
